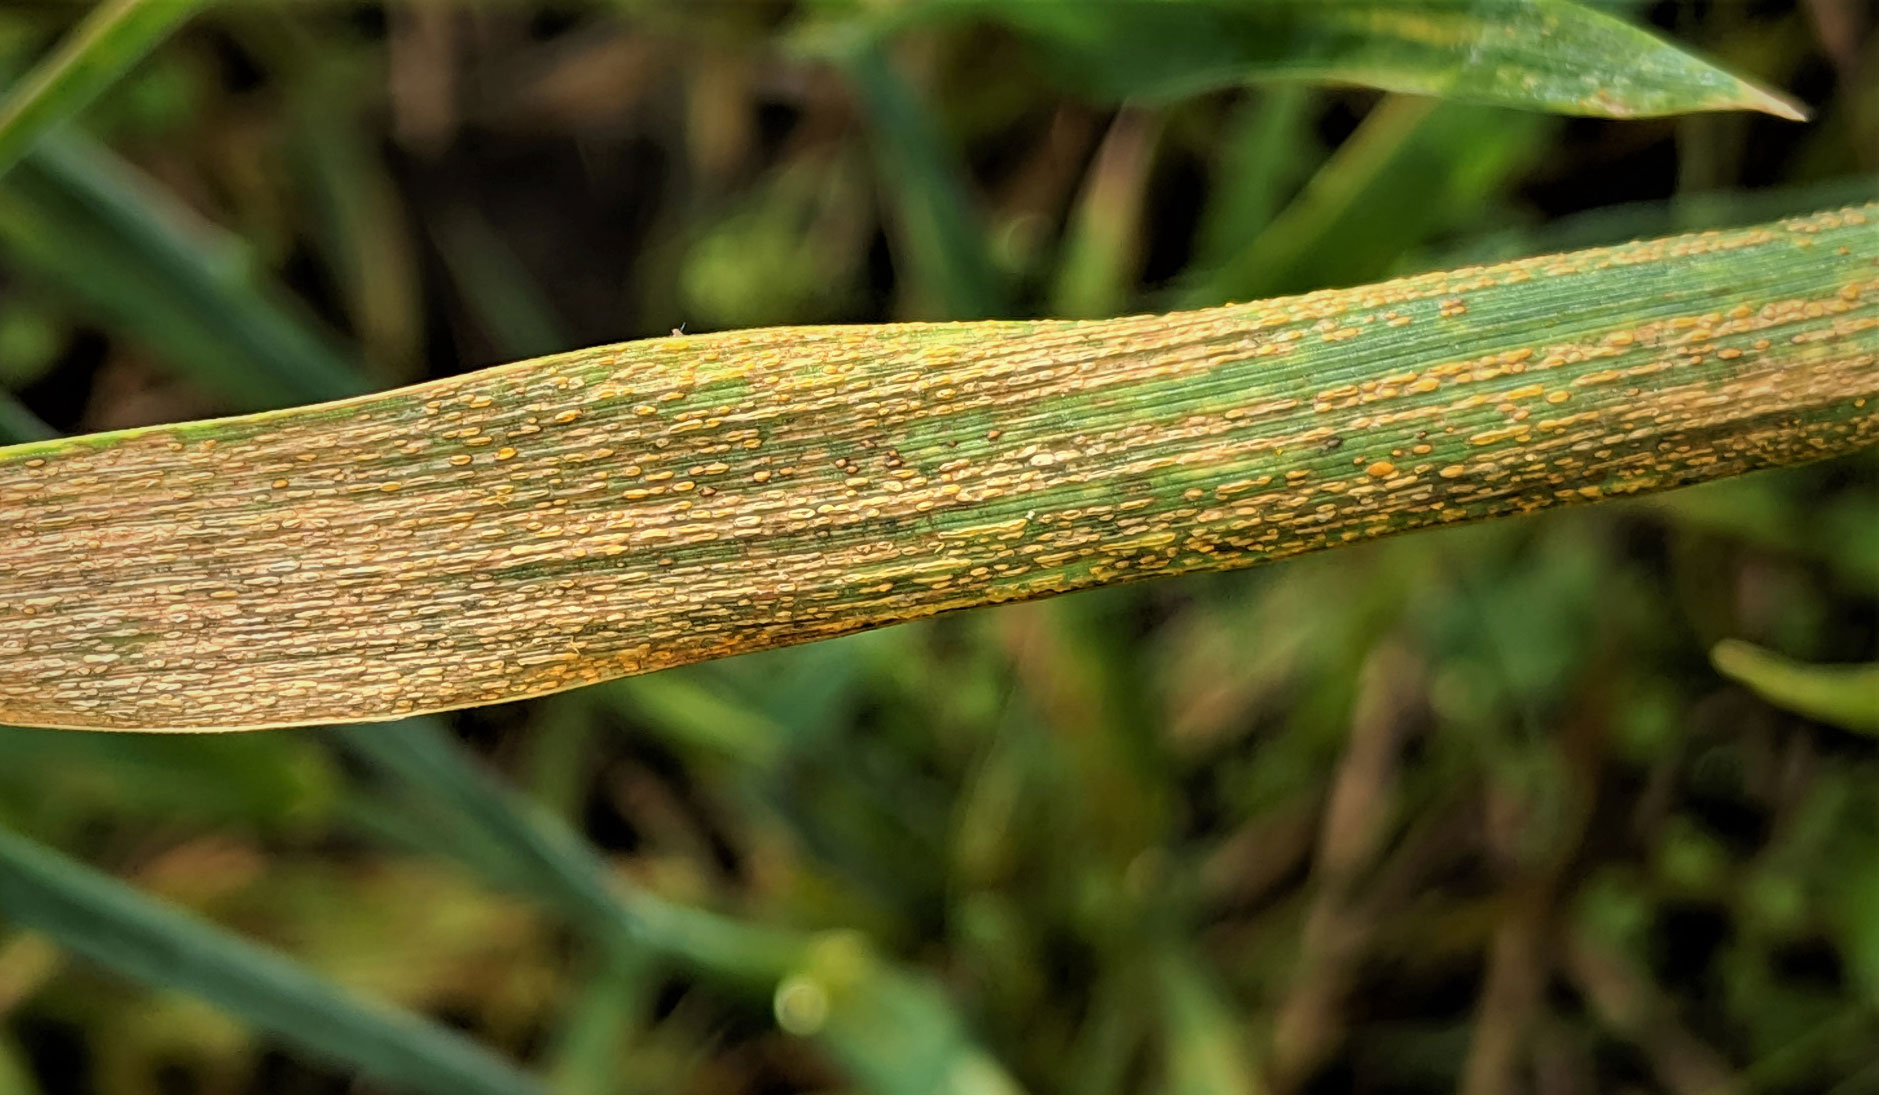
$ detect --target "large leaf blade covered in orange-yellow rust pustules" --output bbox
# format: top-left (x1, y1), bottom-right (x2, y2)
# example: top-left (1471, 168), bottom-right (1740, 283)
top-left (0, 205), bottom-right (1879, 729)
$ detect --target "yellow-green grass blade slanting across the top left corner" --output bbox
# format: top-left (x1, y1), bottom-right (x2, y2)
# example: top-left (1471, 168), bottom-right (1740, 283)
top-left (0, 0), bottom-right (203, 175)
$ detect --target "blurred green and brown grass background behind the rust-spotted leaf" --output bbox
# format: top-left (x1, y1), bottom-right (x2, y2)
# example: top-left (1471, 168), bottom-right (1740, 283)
top-left (0, 0), bottom-right (1879, 1095)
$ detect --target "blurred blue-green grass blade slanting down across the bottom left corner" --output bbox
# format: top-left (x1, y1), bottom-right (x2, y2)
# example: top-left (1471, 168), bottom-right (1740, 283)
top-left (0, 828), bottom-right (537, 1095)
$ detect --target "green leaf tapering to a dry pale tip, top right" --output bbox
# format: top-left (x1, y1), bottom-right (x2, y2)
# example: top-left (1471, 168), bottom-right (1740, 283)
top-left (883, 0), bottom-right (1802, 118)
